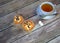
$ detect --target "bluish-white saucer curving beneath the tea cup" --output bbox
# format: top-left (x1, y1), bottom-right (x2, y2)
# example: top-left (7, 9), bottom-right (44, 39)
top-left (36, 6), bottom-right (57, 19)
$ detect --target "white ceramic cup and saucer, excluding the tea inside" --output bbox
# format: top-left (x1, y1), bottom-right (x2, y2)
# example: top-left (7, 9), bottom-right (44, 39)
top-left (36, 2), bottom-right (57, 19)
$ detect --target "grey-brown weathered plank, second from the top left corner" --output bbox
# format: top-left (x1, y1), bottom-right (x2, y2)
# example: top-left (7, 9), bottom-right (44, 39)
top-left (0, 0), bottom-right (37, 17)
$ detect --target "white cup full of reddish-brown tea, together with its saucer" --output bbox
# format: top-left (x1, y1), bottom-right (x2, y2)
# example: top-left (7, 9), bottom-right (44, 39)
top-left (36, 2), bottom-right (57, 19)
